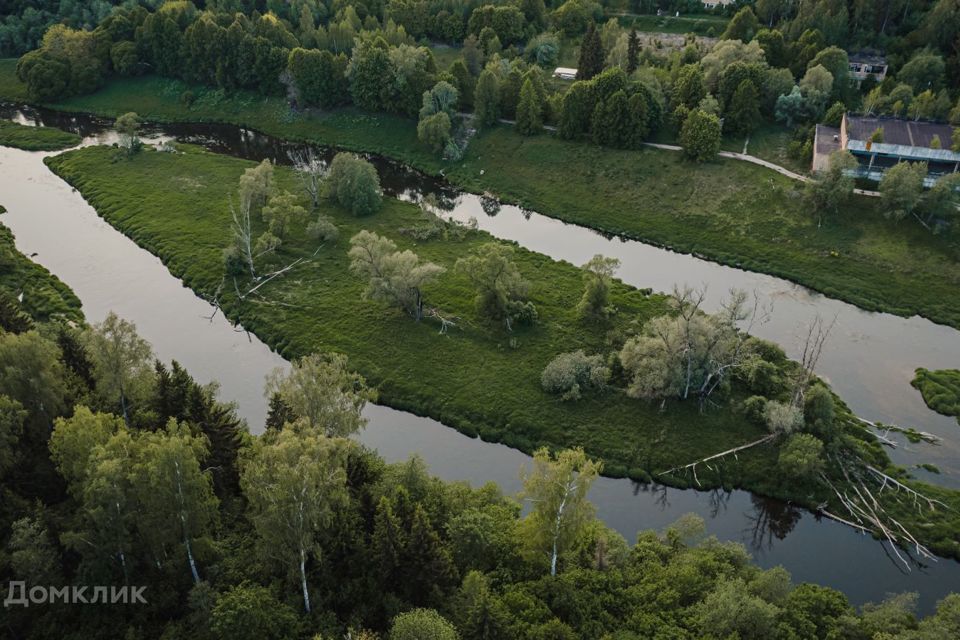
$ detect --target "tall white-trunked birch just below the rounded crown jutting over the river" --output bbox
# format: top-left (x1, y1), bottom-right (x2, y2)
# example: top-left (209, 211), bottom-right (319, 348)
top-left (240, 429), bottom-right (348, 613)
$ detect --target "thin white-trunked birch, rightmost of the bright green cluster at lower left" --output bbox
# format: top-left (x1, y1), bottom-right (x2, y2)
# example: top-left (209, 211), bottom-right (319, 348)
top-left (133, 419), bottom-right (218, 584)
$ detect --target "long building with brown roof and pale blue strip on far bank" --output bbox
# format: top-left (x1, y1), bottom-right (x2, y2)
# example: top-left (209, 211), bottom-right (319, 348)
top-left (813, 114), bottom-right (960, 186)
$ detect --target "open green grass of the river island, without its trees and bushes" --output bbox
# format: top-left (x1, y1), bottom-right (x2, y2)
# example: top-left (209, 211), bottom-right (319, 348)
top-left (49, 147), bottom-right (960, 555)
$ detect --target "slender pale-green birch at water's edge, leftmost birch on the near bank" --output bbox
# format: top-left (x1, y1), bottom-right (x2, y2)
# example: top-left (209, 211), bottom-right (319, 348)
top-left (83, 311), bottom-right (154, 425)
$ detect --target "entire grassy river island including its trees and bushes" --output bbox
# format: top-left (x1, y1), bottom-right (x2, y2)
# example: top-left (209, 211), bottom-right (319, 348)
top-left (48, 142), bottom-right (958, 555)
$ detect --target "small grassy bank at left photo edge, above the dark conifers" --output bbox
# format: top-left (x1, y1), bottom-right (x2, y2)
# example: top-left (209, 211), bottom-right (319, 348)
top-left (0, 206), bottom-right (83, 322)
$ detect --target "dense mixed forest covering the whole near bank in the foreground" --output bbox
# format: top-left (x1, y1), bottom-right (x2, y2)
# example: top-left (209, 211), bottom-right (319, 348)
top-left (0, 224), bottom-right (960, 640)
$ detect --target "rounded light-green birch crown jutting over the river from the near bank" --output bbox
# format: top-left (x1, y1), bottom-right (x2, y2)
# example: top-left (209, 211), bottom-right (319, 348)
top-left (265, 353), bottom-right (375, 438)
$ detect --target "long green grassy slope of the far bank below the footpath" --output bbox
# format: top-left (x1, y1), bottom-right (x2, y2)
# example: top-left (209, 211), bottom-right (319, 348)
top-left (0, 60), bottom-right (960, 327)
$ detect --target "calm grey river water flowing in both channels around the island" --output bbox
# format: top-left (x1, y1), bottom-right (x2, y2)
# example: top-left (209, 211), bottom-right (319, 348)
top-left (0, 107), bottom-right (960, 611)
